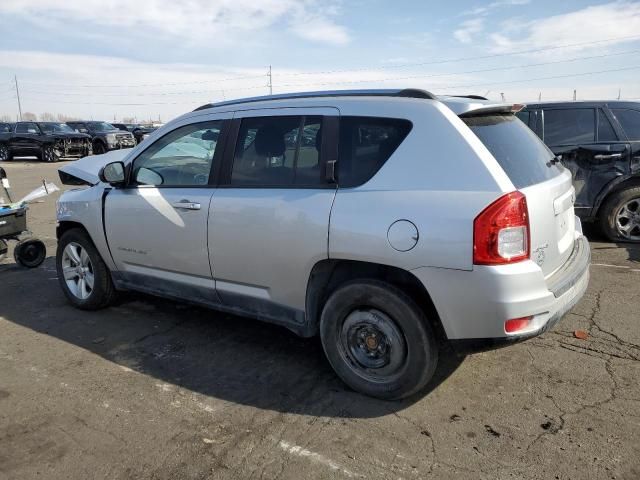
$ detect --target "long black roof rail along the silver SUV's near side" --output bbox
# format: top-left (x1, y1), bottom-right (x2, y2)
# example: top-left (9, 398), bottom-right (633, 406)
top-left (194, 88), bottom-right (437, 112)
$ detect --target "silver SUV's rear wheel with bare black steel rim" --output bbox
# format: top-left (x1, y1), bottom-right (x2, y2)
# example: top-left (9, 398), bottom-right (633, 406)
top-left (320, 280), bottom-right (438, 400)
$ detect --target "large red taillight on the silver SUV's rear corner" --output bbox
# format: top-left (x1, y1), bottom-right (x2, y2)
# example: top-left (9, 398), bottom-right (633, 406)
top-left (473, 192), bottom-right (530, 265)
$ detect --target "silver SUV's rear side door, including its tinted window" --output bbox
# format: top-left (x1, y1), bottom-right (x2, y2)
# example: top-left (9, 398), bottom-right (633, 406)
top-left (209, 108), bottom-right (338, 323)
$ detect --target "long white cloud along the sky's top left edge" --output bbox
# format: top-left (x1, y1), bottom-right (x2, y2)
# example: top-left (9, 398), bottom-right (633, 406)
top-left (0, 0), bottom-right (349, 45)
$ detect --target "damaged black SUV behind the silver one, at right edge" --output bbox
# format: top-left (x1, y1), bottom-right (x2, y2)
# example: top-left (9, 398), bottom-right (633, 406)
top-left (517, 101), bottom-right (640, 242)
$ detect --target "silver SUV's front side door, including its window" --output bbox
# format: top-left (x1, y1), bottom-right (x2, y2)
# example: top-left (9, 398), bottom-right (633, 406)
top-left (105, 120), bottom-right (222, 303)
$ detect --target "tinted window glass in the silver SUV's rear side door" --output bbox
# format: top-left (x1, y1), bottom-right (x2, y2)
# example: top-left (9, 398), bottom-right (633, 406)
top-left (231, 116), bottom-right (325, 186)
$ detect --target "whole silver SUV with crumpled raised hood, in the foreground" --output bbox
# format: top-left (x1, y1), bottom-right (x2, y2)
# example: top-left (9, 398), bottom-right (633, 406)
top-left (57, 89), bottom-right (590, 399)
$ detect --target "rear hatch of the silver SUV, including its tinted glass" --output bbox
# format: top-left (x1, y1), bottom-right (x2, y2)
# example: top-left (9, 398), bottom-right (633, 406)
top-left (461, 113), bottom-right (575, 277)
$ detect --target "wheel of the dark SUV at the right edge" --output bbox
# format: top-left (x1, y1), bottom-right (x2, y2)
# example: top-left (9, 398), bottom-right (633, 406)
top-left (599, 186), bottom-right (640, 243)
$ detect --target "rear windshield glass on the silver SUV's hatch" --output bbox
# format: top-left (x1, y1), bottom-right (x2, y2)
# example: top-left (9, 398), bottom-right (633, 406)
top-left (463, 114), bottom-right (562, 188)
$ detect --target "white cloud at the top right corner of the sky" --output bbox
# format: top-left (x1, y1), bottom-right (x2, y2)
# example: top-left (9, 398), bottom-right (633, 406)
top-left (490, 2), bottom-right (640, 56)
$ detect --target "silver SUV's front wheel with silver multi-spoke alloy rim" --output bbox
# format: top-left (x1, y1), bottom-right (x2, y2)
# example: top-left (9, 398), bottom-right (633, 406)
top-left (56, 228), bottom-right (116, 310)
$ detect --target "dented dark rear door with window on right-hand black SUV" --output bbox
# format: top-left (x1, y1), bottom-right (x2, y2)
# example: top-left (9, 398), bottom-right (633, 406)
top-left (543, 107), bottom-right (630, 217)
